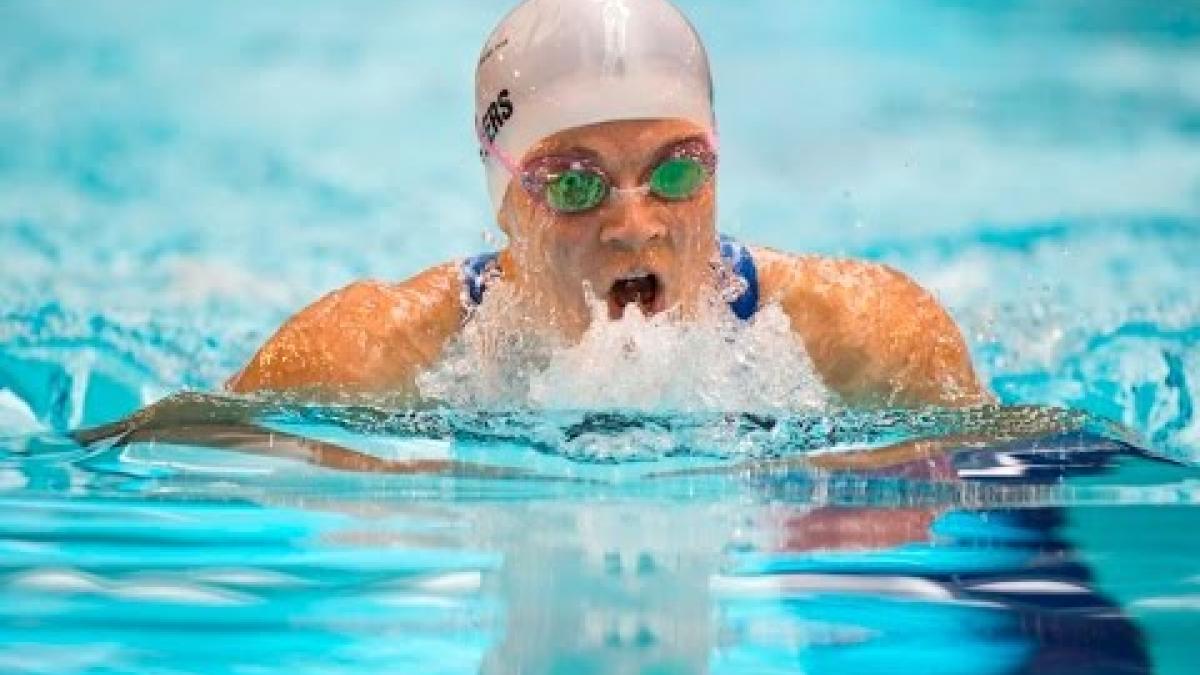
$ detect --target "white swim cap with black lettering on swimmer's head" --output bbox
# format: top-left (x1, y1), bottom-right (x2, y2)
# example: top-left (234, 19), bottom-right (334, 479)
top-left (475, 0), bottom-right (715, 210)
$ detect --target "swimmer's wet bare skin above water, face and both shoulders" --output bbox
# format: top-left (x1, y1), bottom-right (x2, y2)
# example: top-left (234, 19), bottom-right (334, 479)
top-left (228, 120), bottom-right (991, 407)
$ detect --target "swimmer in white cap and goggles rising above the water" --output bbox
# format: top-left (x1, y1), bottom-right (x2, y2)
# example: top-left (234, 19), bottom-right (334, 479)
top-left (228, 0), bottom-right (992, 407)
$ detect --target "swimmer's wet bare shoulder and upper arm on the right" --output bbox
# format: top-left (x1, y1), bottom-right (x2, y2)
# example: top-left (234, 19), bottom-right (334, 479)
top-left (755, 250), bottom-right (995, 407)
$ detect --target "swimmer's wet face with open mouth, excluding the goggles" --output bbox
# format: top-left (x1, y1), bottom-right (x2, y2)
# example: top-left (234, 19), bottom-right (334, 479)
top-left (499, 120), bottom-right (716, 329)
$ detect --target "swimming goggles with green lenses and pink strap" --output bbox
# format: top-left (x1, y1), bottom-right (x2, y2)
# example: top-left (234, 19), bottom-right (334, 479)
top-left (485, 130), bottom-right (716, 214)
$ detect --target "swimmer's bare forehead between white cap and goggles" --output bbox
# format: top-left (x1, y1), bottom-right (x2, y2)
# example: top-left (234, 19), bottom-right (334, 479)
top-left (526, 119), bottom-right (706, 157)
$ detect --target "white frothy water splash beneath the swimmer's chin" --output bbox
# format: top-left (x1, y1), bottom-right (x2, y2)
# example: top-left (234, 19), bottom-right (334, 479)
top-left (418, 278), bottom-right (830, 413)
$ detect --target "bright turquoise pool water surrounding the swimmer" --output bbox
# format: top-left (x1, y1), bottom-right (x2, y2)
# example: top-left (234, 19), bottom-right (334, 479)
top-left (0, 0), bottom-right (1200, 673)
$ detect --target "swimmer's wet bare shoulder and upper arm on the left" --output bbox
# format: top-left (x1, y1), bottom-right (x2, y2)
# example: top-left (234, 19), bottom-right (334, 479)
top-left (226, 263), bottom-right (463, 402)
